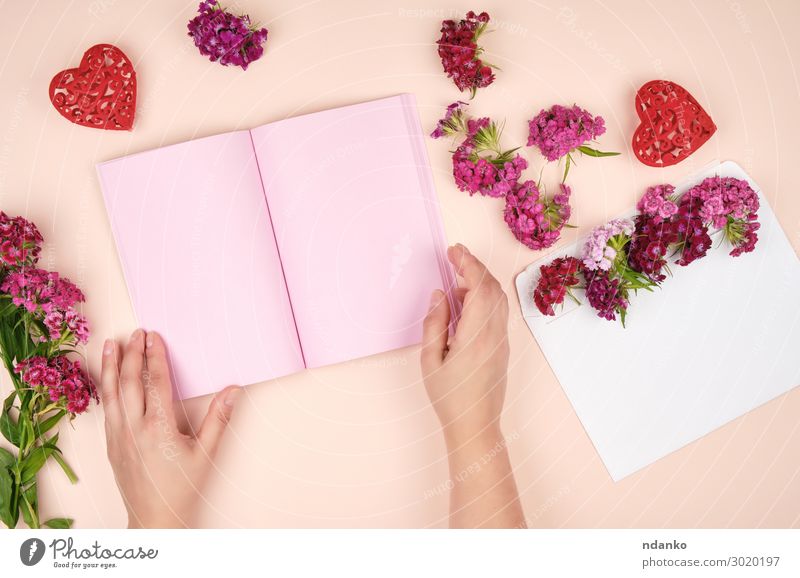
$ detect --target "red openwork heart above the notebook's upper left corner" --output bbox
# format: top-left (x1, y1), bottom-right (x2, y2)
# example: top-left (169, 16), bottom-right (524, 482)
top-left (50, 44), bottom-right (136, 130)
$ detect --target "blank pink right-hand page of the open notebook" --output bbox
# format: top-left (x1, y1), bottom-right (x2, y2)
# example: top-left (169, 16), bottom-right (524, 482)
top-left (251, 95), bottom-right (453, 367)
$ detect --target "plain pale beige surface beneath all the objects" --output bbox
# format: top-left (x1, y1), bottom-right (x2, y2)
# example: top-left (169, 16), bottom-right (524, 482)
top-left (0, 0), bottom-right (800, 527)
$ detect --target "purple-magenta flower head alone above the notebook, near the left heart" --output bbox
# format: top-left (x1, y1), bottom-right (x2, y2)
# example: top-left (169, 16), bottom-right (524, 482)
top-left (188, 0), bottom-right (268, 70)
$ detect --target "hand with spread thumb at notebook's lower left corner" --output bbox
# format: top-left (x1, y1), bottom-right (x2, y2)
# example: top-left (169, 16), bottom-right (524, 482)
top-left (100, 329), bottom-right (241, 528)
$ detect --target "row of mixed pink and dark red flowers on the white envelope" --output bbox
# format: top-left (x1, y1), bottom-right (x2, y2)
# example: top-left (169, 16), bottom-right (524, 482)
top-left (532, 176), bottom-right (760, 326)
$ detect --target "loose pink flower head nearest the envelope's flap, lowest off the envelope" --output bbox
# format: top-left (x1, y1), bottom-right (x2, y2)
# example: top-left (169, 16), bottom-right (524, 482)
top-left (503, 181), bottom-right (570, 250)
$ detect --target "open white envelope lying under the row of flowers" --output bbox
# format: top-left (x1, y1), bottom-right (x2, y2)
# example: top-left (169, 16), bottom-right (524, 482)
top-left (516, 161), bottom-right (800, 481)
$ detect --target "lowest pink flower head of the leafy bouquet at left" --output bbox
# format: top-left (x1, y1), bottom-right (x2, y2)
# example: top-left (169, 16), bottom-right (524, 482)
top-left (14, 355), bottom-right (99, 414)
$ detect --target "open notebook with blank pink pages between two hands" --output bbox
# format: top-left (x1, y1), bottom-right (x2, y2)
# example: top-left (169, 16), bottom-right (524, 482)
top-left (98, 94), bottom-right (454, 398)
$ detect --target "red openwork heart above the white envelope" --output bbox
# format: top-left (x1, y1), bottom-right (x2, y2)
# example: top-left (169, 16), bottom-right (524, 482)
top-left (632, 80), bottom-right (717, 167)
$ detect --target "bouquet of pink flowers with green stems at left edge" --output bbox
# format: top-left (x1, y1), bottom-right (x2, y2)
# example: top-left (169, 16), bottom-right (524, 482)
top-left (0, 211), bottom-right (98, 528)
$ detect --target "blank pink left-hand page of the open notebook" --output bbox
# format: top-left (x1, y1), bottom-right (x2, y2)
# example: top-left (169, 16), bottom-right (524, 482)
top-left (98, 132), bottom-right (304, 398)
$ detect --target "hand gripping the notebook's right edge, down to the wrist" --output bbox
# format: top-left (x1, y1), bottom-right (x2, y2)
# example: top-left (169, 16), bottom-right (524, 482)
top-left (420, 244), bottom-right (509, 447)
